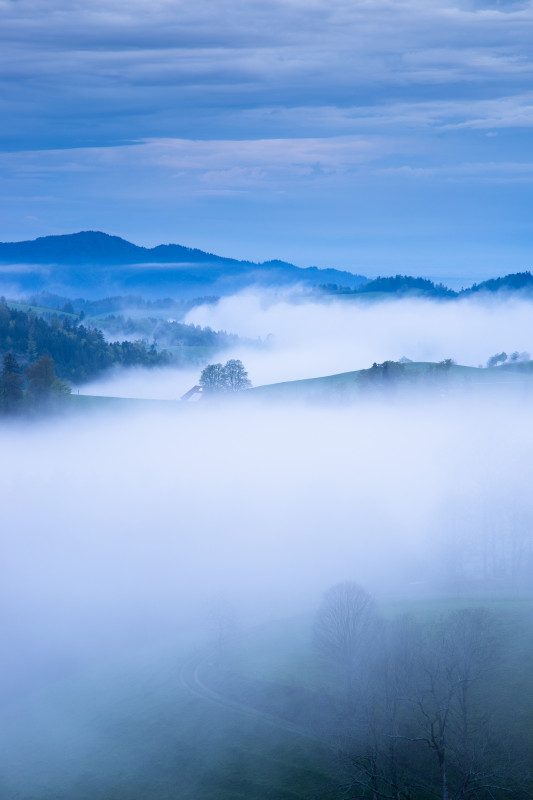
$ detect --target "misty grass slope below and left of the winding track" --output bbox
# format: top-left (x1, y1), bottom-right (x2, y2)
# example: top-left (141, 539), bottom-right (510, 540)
top-left (0, 632), bottom-right (330, 800)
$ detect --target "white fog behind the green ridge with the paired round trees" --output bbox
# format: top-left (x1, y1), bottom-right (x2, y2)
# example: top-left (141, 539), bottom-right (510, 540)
top-left (81, 292), bottom-right (533, 399)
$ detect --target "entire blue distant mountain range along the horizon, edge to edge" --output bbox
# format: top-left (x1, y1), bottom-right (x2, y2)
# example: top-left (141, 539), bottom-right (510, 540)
top-left (0, 231), bottom-right (533, 301)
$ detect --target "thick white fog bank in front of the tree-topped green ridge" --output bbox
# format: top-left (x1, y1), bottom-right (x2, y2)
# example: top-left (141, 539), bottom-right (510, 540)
top-left (1, 402), bottom-right (533, 672)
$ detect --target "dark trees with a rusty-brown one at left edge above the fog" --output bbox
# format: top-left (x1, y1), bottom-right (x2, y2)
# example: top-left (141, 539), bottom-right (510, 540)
top-left (0, 353), bottom-right (70, 415)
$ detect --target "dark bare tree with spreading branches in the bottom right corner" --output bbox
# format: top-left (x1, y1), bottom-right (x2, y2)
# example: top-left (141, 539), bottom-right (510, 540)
top-left (398, 608), bottom-right (520, 800)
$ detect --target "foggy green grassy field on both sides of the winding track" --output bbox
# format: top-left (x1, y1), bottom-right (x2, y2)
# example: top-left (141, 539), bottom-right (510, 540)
top-left (0, 599), bottom-right (533, 800)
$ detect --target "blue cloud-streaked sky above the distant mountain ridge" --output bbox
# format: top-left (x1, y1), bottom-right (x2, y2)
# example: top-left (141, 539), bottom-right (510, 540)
top-left (0, 0), bottom-right (533, 284)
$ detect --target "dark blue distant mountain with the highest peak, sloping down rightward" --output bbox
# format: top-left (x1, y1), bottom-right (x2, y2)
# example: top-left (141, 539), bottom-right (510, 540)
top-left (0, 231), bottom-right (367, 298)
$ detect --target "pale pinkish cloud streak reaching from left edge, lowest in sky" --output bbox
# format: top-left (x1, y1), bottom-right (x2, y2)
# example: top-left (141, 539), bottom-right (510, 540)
top-left (0, 136), bottom-right (389, 191)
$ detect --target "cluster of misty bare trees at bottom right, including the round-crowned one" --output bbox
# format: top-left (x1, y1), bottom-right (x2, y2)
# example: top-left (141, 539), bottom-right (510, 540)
top-left (314, 582), bottom-right (527, 800)
